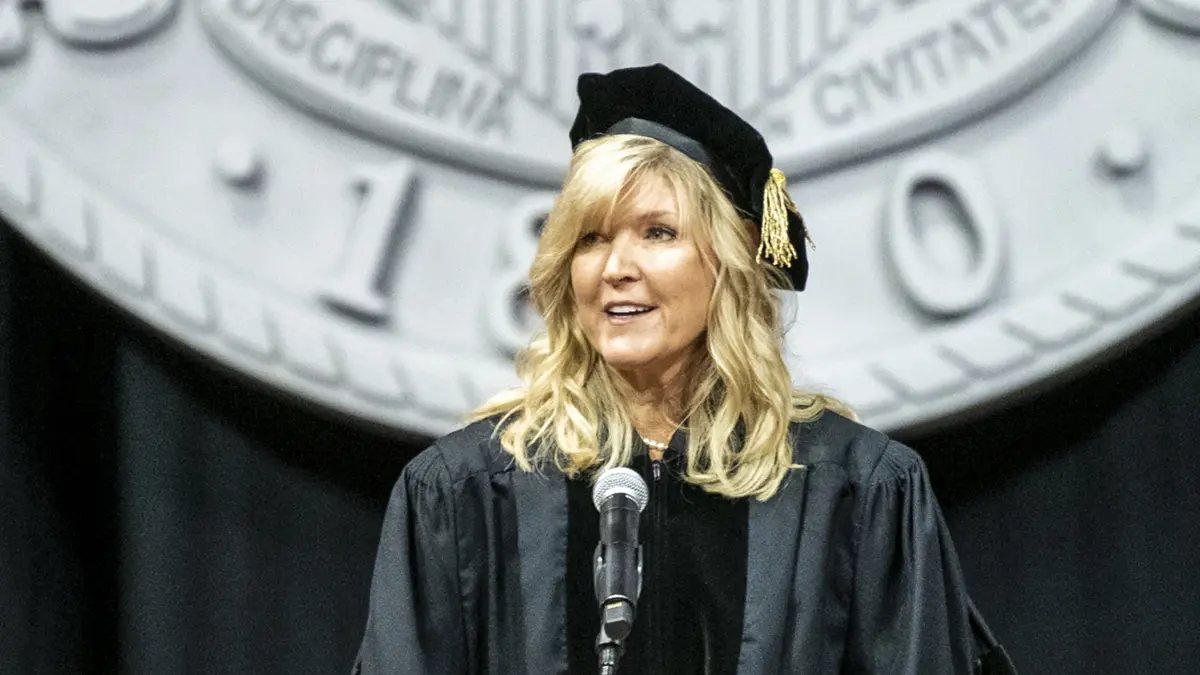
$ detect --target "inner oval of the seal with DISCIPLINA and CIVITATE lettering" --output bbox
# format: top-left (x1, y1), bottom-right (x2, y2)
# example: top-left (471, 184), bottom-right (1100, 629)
top-left (202, 0), bottom-right (1117, 185)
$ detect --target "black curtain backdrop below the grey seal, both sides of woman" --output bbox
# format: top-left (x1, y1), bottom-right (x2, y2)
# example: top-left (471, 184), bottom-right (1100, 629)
top-left (0, 226), bottom-right (1200, 675)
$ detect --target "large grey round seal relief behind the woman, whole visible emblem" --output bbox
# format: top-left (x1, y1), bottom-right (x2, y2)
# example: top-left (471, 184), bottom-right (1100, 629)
top-left (0, 0), bottom-right (1200, 434)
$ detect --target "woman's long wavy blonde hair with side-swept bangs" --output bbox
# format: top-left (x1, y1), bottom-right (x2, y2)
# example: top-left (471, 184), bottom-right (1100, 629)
top-left (470, 136), bottom-right (852, 500)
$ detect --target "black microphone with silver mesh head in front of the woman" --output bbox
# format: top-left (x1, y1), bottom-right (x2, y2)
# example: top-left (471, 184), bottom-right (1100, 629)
top-left (592, 467), bottom-right (650, 674)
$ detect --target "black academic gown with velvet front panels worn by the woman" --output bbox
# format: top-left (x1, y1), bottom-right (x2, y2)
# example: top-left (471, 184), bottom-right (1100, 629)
top-left (355, 412), bottom-right (1013, 675)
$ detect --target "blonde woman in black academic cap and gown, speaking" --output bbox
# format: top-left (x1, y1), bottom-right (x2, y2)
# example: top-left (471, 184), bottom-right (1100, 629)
top-left (356, 66), bottom-right (1012, 675)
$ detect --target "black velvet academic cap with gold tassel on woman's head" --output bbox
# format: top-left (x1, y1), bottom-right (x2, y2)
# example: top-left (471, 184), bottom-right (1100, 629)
top-left (571, 64), bottom-right (809, 291)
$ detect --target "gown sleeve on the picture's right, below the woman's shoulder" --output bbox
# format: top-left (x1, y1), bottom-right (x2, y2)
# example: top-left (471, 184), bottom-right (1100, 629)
top-left (847, 442), bottom-right (1015, 675)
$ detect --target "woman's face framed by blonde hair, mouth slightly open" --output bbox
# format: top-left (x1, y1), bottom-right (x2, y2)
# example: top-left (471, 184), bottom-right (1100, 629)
top-left (571, 179), bottom-right (713, 377)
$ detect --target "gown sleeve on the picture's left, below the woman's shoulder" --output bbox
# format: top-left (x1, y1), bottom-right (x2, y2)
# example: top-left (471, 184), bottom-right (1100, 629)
top-left (353, 448), bottom-right (467, 675)
